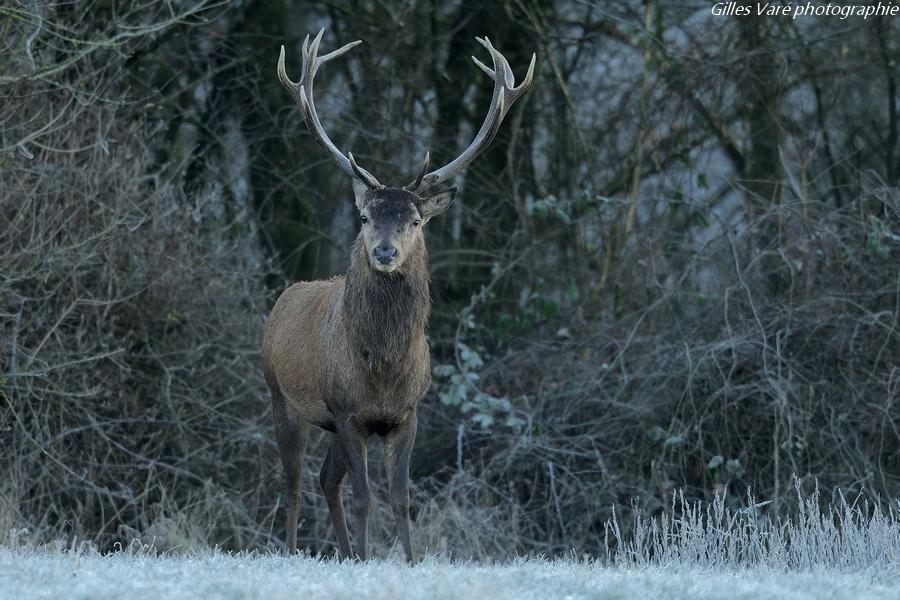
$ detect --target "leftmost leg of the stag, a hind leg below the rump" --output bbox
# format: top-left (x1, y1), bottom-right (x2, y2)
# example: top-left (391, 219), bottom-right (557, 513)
top-left (271, 385), bottom-right (309, 554)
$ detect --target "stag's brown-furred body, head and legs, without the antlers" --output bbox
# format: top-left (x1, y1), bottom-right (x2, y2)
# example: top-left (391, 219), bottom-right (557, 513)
top-left (262, 190), bottom-right (442, 560)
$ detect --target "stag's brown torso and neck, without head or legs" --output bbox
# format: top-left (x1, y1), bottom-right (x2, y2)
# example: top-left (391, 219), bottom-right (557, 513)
top-left (263, 236), bottom-right (431, 430)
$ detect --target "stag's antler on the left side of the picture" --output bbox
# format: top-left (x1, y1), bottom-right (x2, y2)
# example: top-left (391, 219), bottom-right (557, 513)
top-left (278, 27), bottom-right (384, 189)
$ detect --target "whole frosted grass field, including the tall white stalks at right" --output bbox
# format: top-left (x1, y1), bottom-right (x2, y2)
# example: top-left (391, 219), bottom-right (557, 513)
top-left (0, 494), bottom-right (900, 600)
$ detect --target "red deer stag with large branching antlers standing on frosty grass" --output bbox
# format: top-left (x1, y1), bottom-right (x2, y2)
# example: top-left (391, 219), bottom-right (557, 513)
top-left (262, 28), bottom-right (536, 563)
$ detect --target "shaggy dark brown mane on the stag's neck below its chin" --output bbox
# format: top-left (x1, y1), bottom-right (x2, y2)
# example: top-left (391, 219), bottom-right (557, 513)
top-left (343, 236), bottom-right (431, 371)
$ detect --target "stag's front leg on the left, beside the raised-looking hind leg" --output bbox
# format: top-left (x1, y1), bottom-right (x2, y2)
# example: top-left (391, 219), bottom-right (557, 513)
top-left (336, 418), bottom-right (371, 560)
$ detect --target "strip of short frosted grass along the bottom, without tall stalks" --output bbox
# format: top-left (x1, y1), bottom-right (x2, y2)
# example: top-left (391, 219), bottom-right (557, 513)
top-left (0, 549), bottom-right (900, 600)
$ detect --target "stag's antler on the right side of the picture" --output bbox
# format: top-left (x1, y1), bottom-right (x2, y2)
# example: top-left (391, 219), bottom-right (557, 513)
top-left (407, 37), bottom-right (537, 191)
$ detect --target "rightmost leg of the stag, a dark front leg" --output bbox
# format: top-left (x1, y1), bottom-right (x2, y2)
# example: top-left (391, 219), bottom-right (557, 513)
top-left (384, 409), bottom-right (416, 563)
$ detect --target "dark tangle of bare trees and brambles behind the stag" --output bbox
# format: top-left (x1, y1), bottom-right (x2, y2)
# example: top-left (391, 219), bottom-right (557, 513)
top-left (0, 0), bottom-right (900, 559)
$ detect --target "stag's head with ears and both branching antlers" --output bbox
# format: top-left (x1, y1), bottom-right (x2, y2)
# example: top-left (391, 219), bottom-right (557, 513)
top-left (278, 28), bottom-right (536, 273)
